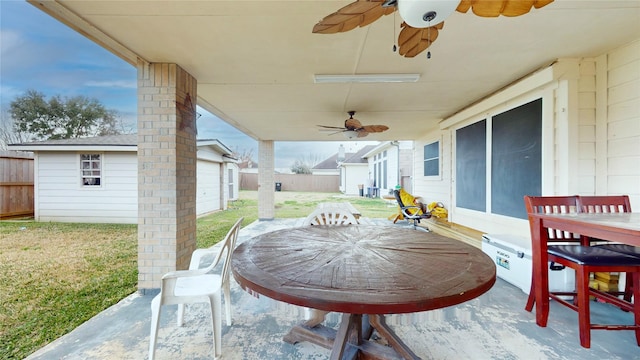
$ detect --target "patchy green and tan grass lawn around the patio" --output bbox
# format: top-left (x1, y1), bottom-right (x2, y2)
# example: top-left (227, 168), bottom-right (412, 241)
top-left (0, 191), bottom-right (396, 359)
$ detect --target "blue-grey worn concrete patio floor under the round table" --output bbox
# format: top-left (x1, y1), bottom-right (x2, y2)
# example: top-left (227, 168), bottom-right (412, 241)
top-left (27, 219), bottom-right (640, 360)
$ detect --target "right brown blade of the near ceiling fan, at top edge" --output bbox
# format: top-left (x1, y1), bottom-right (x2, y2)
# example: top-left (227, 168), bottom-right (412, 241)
top-left (456, 0), bottom-right (553, 17)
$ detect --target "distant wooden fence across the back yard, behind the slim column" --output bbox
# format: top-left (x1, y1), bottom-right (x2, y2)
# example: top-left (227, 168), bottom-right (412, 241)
top-left (240, 172), bottom-right (340, 192)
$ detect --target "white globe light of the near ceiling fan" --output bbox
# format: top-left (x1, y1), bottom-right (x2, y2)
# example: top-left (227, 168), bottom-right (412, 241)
top-left (398, 0), bottom-right (460, 28)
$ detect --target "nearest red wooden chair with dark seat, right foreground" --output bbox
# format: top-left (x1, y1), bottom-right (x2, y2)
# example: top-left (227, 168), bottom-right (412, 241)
top-left (524, 196), bottom-right (640, 348)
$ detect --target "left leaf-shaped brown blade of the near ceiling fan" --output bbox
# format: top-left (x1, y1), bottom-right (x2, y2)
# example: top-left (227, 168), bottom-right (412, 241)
top-left (312, 0), bottom-right (396, 34)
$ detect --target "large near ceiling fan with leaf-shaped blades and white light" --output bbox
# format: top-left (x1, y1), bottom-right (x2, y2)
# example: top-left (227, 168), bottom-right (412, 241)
top-left (313, 0), bottom-right (553, 57)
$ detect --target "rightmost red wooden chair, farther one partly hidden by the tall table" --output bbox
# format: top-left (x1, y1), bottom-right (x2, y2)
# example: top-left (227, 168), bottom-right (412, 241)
top-left (578, 195), bottom-right (640, 302)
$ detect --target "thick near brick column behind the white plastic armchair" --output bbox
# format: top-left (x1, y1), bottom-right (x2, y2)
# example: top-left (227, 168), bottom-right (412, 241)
top-left (138, 61), bottom-right (197, 294)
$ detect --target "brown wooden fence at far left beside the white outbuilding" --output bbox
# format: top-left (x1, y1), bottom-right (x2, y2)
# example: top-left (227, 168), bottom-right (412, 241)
top-left (0, 151), bottom-right (34, 219)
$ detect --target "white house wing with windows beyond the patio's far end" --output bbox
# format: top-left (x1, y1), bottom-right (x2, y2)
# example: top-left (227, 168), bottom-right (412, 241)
top-left (363, 141), bottom-right (413, 196)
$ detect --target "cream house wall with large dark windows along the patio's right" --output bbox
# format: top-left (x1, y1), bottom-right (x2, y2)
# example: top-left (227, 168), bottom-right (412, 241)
top-left (413, 41), bottom-right (640, 238)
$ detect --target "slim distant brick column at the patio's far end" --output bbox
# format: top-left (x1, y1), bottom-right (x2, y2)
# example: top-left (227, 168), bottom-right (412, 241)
top-left (258, 140), bottom-right (276, 220)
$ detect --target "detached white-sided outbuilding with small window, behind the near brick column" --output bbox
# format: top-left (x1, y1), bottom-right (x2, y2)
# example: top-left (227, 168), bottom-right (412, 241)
top-left (9, 134), bottom-right (239, 224)
